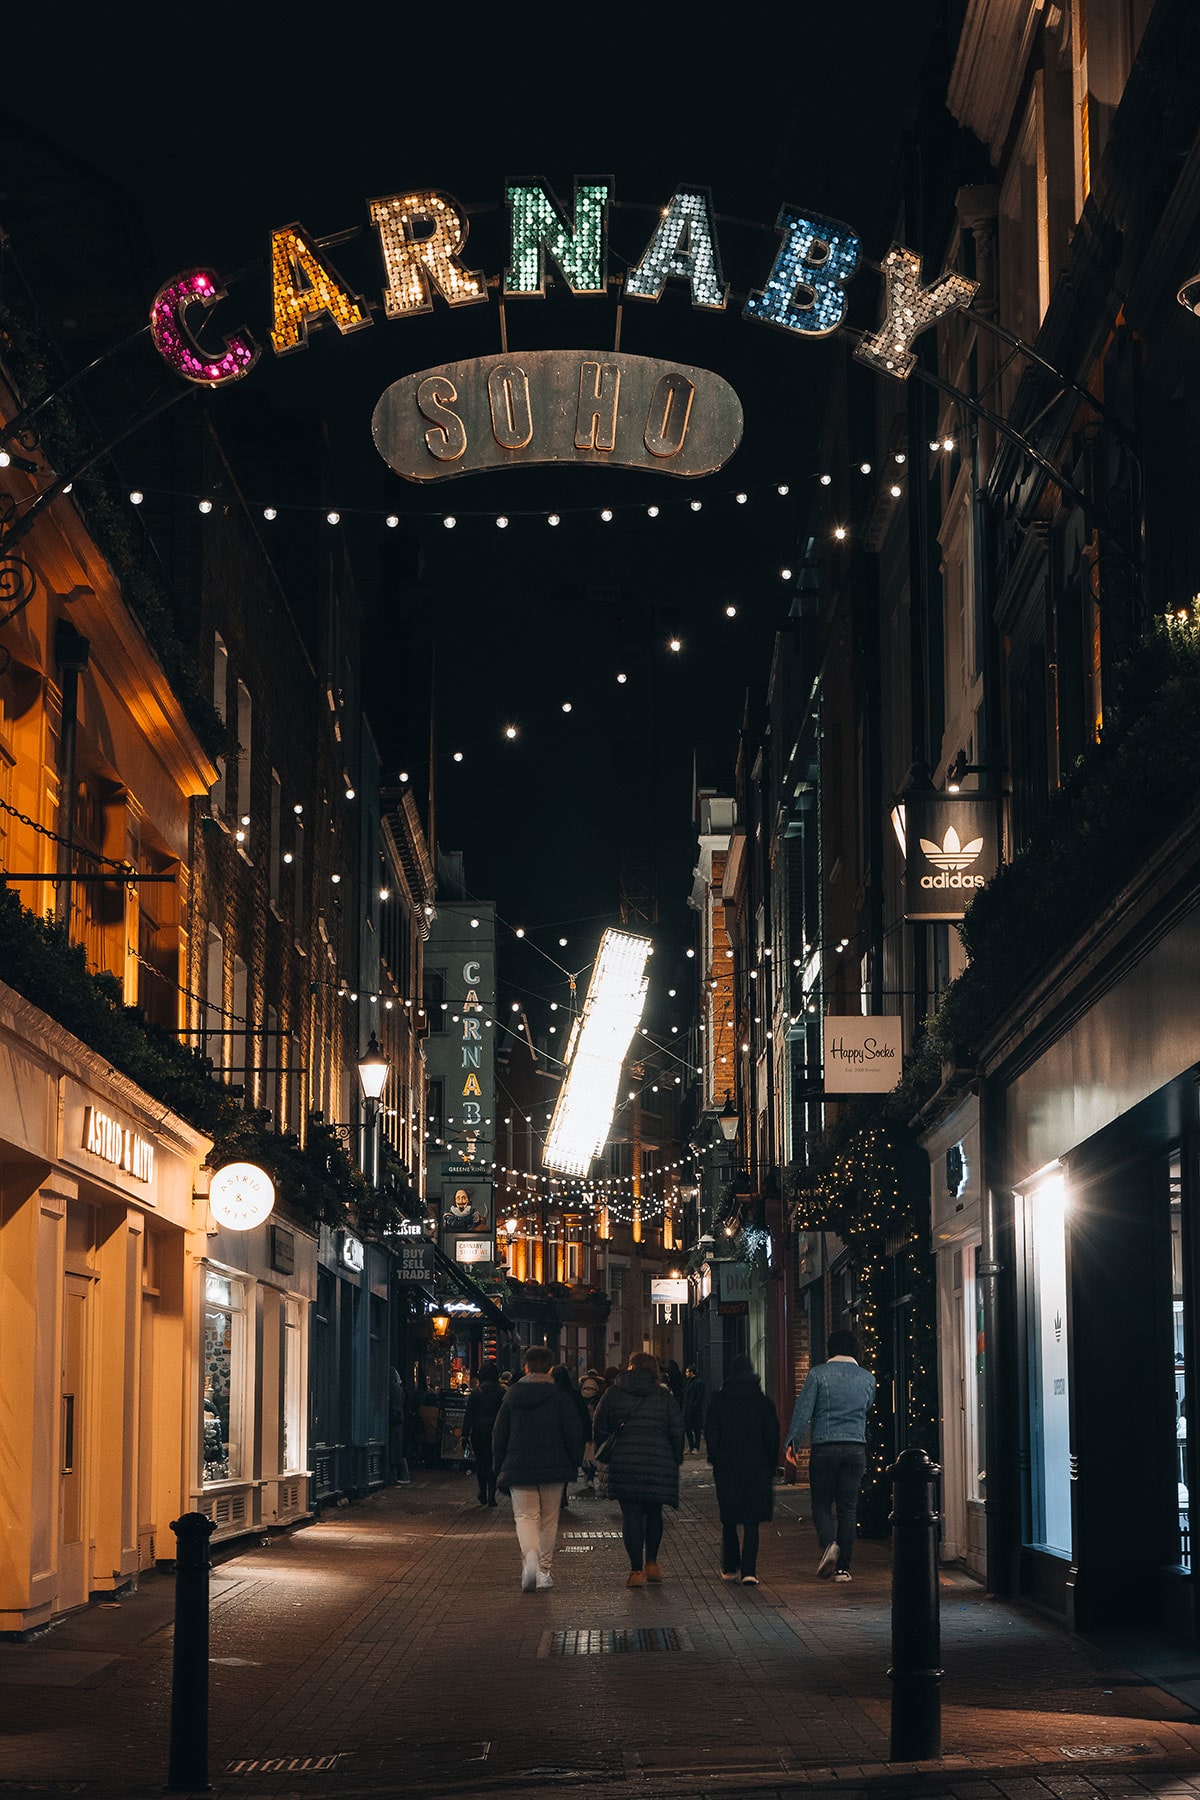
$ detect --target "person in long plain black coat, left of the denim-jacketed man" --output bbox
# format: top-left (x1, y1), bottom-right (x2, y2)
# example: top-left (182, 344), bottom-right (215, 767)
top-left (703, 1355), bottom-right (779, 1588)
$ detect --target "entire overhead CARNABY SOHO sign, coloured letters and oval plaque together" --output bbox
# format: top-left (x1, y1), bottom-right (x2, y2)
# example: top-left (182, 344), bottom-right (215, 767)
top-left (149, 180), bottom-right (979, 481)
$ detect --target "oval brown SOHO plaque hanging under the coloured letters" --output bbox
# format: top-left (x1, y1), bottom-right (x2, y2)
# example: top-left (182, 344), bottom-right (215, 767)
top-left (371, 349), bottom-right (741, 481)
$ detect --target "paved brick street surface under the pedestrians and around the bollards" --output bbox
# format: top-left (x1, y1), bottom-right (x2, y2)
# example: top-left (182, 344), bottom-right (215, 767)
top-left (0, 1458), bottom-right (1200, 1800)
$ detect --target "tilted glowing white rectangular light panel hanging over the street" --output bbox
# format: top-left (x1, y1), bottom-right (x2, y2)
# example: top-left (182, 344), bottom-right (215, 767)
top-left (542, 931), bottom-right (649, 1175)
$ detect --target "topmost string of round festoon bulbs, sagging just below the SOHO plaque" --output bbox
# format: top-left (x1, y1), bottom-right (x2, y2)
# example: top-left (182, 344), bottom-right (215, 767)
top-left (107, 457), bottom-right (928, 540)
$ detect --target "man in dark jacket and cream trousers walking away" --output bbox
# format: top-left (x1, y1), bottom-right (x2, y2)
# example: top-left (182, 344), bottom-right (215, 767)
top-left (491, 1345), bottom-right (583, 1593)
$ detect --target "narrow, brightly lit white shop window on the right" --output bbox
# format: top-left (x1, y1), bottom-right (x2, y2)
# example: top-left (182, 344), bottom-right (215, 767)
top-left (1025, 1174), bottom-right (1070, 1557)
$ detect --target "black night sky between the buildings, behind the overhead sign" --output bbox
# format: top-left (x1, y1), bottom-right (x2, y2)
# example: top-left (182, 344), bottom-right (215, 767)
top-left (5, 10), bottom-right (937, 1029)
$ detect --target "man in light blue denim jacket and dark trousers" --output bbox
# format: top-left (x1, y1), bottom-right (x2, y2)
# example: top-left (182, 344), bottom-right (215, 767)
top-left (788, 1332), bottom-right (874, 1582)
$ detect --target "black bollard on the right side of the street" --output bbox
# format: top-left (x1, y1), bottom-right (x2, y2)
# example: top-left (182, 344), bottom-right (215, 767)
top-left (887, 1451), bottom-right (943, 1762)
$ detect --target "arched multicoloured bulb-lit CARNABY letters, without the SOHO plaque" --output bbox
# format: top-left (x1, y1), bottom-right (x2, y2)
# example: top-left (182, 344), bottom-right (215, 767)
top-left (149, 180), bottom-right (977, 412)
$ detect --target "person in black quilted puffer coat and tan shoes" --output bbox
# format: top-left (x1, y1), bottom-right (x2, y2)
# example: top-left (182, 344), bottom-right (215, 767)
top-left (594, 1350), bottom-right (684, 1588)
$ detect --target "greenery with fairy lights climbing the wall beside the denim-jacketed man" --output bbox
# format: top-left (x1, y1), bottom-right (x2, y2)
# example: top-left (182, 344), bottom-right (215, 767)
top-left (793, 1123), bottom-right (937, 1535)
